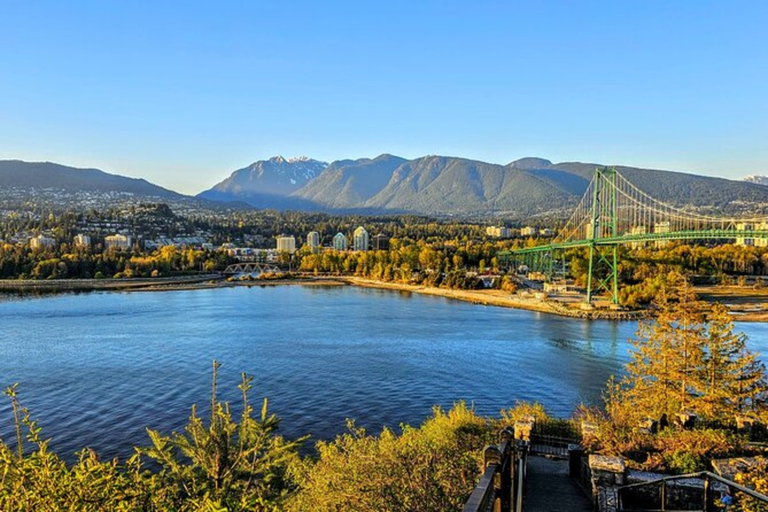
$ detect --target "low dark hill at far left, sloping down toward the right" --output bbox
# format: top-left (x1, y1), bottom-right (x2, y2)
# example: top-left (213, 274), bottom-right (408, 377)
top-left (0, 160), bottom-right (184, 199)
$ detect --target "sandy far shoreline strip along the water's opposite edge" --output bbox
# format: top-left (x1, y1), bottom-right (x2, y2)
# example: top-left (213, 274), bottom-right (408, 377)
top-left (0, 274), bottom-right (768, 322)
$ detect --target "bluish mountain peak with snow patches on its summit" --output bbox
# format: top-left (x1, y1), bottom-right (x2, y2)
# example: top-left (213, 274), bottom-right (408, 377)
top-left (197, 156), bottom-right (328, 209)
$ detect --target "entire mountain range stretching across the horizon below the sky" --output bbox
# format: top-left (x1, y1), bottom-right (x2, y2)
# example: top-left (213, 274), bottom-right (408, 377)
top-left (0, 154), bottom-right (768, 219)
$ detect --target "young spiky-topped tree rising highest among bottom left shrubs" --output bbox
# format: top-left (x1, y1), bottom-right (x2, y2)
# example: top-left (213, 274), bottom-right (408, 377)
top-left (142, 361), bottom-right (306, 510)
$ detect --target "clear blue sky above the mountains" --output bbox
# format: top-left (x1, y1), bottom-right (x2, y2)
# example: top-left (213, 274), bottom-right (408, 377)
top-left (0, 0), bottom-right (768, 194)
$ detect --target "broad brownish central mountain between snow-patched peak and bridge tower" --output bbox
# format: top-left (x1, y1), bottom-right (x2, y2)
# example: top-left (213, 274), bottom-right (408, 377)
top-left (293, 155), bottom-right (574, 215)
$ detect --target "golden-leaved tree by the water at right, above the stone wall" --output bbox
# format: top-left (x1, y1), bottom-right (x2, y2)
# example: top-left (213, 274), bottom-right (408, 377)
top-left (607, 274), bottom-right (766, 421)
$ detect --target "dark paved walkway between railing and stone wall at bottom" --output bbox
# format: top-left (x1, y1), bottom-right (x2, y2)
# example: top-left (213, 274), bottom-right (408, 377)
top-left (523, 456), bottom-right (593, 512)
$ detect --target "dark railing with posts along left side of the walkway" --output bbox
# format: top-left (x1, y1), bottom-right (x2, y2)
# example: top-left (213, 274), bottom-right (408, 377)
top-left (464, 429), bottom-right (529, 512)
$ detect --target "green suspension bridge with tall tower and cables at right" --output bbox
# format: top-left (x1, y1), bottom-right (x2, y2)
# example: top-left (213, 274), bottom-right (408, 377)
top-left (499, 168), bottom-right (768, 304)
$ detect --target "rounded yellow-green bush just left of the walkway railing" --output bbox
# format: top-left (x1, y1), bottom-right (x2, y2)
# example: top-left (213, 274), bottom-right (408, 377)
top-left (288, 403), bottom-right (493, 512)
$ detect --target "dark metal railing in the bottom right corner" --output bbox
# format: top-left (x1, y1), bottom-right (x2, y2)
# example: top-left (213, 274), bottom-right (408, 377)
top-left (617, 471), bottom-right (768, 512)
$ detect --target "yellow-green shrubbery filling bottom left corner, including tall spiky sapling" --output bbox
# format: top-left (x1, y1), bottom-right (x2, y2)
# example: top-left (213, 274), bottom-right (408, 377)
top-left (0, 362), bottom-right (303, 511)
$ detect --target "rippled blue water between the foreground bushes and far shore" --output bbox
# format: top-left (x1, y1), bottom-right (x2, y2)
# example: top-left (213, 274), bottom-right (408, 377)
top-left (0, 286), bottom-right (768, 458)
